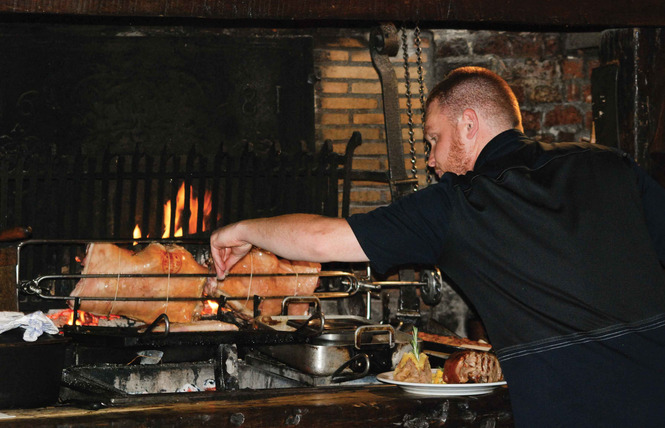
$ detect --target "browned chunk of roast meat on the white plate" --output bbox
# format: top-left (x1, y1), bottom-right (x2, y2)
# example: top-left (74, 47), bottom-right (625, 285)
top-left (443, 351), bottom-right (503, 383)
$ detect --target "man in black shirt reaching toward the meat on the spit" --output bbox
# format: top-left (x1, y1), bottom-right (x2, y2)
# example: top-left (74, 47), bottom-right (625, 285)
top-left (211, 67), bottom-right (665, 428)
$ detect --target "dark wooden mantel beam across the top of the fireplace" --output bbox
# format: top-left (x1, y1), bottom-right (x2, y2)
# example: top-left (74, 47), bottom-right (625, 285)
top-left (0, 0), bottom-right (665, 29)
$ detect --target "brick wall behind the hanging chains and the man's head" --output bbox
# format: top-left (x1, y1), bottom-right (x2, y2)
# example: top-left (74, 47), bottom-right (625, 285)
top-left (314, 29), bottom-right (598, 213)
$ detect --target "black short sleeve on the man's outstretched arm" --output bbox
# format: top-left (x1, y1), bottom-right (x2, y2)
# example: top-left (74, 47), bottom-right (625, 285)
top-left (347, 182), bottom-right (451, 273)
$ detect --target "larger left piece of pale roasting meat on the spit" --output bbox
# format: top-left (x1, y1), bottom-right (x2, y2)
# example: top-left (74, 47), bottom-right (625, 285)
top-left (68, 243), bottom-right (209, 323)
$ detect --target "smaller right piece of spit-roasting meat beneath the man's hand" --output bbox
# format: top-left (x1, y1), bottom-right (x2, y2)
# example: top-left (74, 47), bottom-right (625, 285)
top-left (209, 248), bottom-right (321, 319)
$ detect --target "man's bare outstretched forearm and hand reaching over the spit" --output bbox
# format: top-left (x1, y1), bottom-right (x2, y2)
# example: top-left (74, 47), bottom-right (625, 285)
top-left (210, 214), bottom-right (368, 278)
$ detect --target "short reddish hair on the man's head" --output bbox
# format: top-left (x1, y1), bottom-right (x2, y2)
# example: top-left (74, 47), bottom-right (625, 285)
top-left (425, 67), bottom-right (522, 129)
